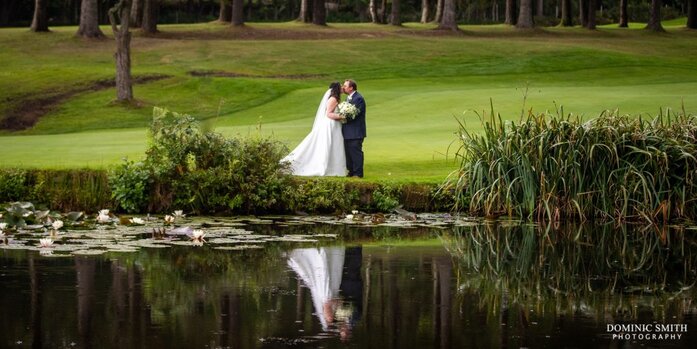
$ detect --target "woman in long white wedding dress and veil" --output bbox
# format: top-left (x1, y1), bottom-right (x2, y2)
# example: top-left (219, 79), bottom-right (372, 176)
top-left (281, 82), bottom-right (346, 176)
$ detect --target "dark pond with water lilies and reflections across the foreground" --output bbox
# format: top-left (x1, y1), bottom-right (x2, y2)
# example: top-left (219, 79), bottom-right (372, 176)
top-left (0, 215), bottom-right (697, 348)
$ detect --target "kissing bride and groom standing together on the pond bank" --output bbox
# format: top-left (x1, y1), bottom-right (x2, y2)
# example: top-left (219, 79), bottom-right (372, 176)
top-left (281, 80), bottom-right (366, 178)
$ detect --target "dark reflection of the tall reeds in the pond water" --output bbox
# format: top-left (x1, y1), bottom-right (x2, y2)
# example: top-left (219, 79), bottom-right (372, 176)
top-left (443, 225), bottom-right (697, 320)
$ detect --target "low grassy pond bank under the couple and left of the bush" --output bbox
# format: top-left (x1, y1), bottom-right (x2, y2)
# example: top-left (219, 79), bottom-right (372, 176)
top-left (0, 169), bottom-right (454, 214)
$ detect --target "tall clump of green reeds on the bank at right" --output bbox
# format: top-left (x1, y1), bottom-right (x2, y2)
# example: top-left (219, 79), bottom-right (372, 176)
top-left (445, 109), bottom-right (697, 222)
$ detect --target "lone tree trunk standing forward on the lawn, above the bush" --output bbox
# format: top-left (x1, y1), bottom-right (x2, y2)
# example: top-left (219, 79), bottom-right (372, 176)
top-left (109, 0), bottom-right (134, 102)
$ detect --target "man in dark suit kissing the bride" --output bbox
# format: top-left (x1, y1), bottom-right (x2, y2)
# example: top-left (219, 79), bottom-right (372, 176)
top-left (341, 80), bottom-right (366, 178)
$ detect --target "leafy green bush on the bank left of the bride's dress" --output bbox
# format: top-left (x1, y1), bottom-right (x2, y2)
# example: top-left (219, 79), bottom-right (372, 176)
top-left (109, 108), bottom-right (291, 213)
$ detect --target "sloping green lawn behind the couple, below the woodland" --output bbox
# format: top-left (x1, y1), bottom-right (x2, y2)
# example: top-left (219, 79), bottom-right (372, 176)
top-left (0, 19), bottom-right (697, 181)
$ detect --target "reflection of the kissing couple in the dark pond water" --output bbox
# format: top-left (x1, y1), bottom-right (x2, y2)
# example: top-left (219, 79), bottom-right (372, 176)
top-left (288, 246), bottom-right (363, 339)
